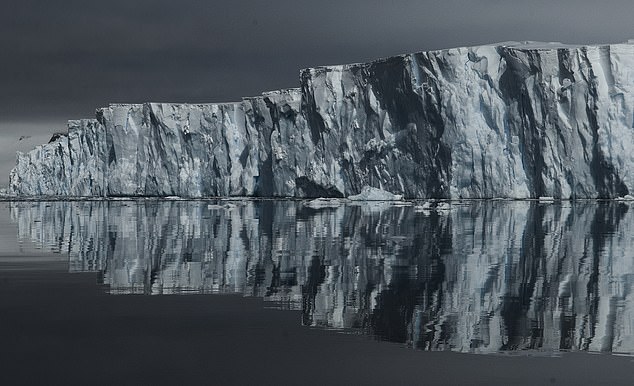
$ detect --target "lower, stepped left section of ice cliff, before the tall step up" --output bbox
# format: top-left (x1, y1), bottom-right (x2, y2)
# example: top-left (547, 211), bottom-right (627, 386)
top-left (9, 90), bottom-right (306, 197)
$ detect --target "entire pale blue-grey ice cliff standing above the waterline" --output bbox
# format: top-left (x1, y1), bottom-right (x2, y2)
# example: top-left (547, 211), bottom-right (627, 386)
top-left (9, 42), bottom-right (634, 199)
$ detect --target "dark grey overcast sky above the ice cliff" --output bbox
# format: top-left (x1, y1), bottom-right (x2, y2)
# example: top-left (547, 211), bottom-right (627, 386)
top-left (0, 0), bottom-right (634, 184)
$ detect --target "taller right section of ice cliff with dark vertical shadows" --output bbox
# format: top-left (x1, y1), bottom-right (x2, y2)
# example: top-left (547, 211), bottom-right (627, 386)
top-left (302, 44), bottom-right (634, 198)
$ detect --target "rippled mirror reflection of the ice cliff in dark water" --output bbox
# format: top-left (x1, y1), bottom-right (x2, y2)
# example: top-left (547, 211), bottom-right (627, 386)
top-left (11, 201), bottom-right (634, 353)
